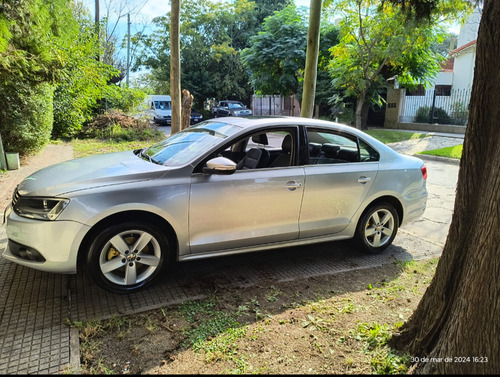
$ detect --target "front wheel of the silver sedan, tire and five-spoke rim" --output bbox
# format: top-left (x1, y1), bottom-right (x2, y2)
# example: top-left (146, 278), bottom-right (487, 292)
top-left (86, 222), bottom-right (170, 293)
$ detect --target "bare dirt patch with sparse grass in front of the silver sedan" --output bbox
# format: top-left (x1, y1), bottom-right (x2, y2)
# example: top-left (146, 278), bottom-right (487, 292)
top-left (75, 260), bottom-right (436, 374)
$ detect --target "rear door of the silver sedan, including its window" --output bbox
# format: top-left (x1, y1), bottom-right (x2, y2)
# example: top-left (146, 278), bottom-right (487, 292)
top-left (299, 129), bottom-right (379, 238)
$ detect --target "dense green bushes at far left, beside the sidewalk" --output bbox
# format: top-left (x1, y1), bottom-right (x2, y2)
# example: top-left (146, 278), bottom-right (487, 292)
top-left (0, 0), bottom-right (117, 154)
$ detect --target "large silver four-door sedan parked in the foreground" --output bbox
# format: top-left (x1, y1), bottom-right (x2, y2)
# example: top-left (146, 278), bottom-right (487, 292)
top-left (3, 117), bottom-right (427, 293)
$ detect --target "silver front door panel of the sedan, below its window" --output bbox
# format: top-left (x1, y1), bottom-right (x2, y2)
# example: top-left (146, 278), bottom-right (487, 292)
top-left (189, 167), bottom-right (304, 253)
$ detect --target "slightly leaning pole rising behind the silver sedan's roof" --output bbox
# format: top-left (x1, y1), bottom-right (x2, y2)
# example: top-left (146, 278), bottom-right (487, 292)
top-left (300, 0), bottom-right (321, 118)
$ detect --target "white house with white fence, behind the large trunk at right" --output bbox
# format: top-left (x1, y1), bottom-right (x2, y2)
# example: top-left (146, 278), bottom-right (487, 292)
top-left (384, 8), bottom-right (481, 133)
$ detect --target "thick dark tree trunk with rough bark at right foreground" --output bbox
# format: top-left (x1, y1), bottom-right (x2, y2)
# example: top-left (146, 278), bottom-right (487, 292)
top-left (390, 0), bottom-right (500, 374)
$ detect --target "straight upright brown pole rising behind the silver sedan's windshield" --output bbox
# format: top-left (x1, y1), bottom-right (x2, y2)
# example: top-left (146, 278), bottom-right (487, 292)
top-left (170, 0), bottom-right (181, 135)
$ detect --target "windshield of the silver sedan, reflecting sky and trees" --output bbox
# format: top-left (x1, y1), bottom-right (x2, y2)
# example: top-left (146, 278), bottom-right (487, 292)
top-left (141, 121), bottom-right (241, 167)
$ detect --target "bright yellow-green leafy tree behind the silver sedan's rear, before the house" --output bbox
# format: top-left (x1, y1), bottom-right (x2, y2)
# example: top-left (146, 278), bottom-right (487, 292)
top-left (329, 0), bottom-right (470, 126)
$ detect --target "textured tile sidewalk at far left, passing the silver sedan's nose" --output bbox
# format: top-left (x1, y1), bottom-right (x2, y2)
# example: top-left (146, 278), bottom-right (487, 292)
top-left (0, 144), bottom-right (80, 374)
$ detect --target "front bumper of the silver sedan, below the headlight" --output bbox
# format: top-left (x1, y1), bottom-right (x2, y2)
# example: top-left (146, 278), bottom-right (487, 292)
top-left (2, 210), bottom-right (89, 274)
